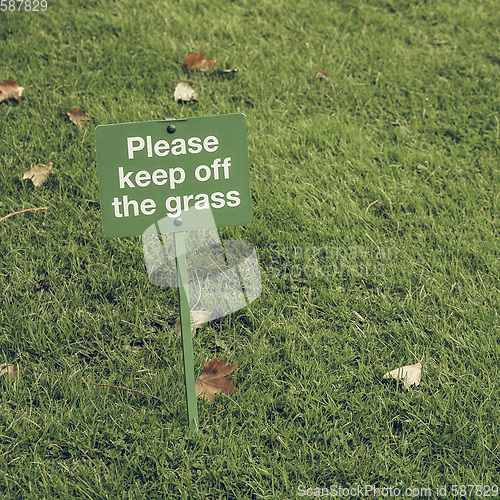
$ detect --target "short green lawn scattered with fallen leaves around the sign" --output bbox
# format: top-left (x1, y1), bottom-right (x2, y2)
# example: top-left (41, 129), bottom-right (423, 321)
top-left (0, 0), bottom-right (500, 499)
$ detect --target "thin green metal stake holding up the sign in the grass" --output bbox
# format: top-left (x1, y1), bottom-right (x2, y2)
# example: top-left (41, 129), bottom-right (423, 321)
top-left (174, 229), bottom-right (198, 432)
